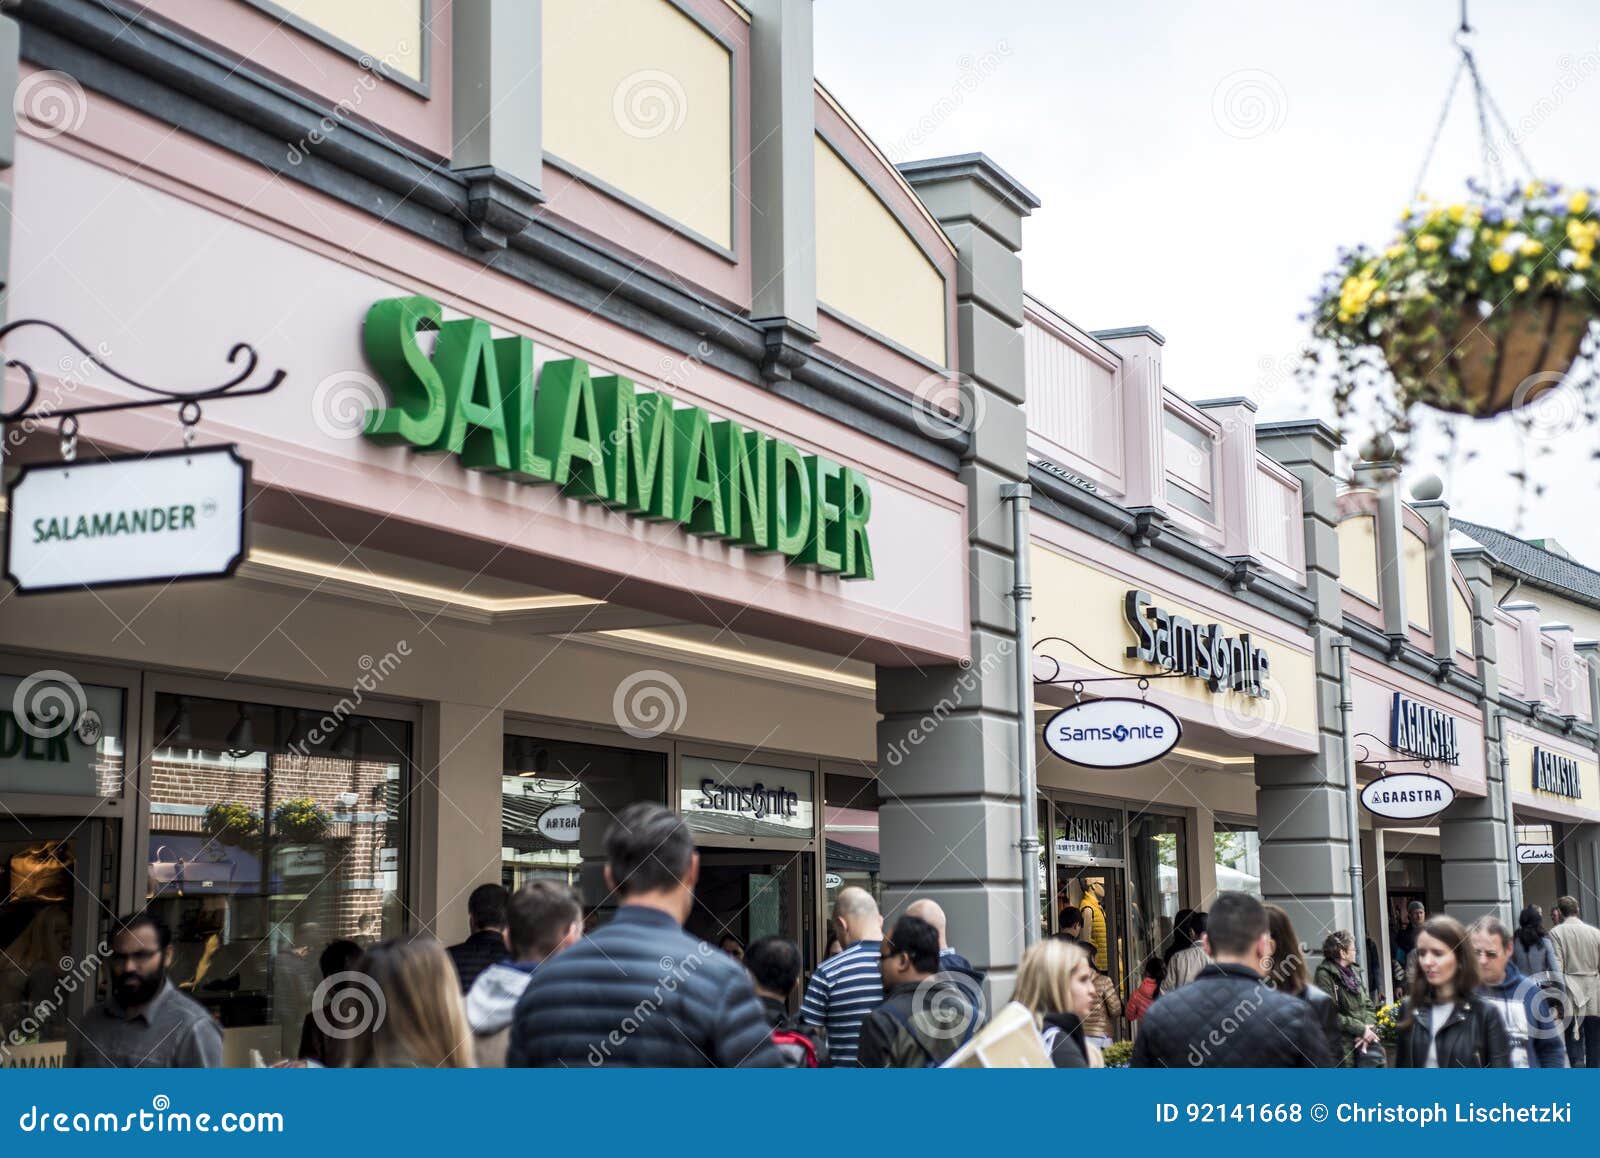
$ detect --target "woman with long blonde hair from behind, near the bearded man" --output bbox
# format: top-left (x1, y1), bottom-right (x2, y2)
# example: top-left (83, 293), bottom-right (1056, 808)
top-left (345, 936), bottom-right (474, 1070)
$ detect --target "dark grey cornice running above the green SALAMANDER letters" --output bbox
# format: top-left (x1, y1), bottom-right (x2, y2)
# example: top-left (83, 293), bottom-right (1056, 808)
top-left (14, 0), bottom-right (971, 472)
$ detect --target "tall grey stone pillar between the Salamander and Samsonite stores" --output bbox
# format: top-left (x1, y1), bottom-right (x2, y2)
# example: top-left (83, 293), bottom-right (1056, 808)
top-left (877, 155), bottom-right (1038, 1001)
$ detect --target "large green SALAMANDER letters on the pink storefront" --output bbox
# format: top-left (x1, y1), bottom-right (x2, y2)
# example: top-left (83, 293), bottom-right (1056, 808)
top-left (363, 296), bottom-right (872, 579)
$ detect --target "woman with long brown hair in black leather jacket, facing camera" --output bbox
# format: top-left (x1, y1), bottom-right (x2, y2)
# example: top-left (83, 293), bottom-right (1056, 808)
top-left (1395, 916), bottom-right (1510, 1070)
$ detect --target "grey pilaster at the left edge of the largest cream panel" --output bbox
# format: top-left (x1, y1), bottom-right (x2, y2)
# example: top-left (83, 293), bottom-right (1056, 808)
top-left (450, 0), bottom-right (544, 250)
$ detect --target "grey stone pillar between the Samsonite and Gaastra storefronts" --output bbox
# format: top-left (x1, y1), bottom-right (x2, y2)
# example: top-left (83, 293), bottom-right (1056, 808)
top-left (1256, 419), bottom-right (1350, 961)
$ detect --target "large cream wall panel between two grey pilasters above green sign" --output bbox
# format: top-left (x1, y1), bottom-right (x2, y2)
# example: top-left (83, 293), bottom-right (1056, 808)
top-left (542, 0), bottom-right (733, 250)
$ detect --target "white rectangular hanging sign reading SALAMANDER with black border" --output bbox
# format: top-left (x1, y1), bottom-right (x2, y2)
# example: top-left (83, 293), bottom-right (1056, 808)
top-left (5, 446), bottom-right (250, 595)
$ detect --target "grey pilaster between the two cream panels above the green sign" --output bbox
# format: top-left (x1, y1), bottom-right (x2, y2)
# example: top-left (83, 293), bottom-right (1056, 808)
top-left (749, 0), bottom-right (816, 359)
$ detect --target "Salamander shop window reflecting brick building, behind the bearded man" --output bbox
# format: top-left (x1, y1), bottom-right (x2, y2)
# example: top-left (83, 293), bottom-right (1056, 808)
top-left (147, 694), bottom-right (411, 1064)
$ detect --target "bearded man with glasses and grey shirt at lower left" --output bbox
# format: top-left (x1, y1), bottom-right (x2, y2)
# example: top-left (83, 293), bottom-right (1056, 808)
top-left (67, 912), bottom-right (222, 1068)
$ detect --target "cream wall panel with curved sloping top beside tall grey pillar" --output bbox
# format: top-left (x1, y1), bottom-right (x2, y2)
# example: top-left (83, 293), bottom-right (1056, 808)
top-left (816, 138), bottom-right (946, 366)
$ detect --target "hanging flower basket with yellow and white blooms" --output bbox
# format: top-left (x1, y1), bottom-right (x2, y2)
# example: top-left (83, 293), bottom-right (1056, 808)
top-left (1310, 182), bottom-right (1600, 424)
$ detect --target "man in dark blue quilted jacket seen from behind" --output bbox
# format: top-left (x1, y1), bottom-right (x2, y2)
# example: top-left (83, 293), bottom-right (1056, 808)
top-left (506, 803), bottom-right (782, 1067)
